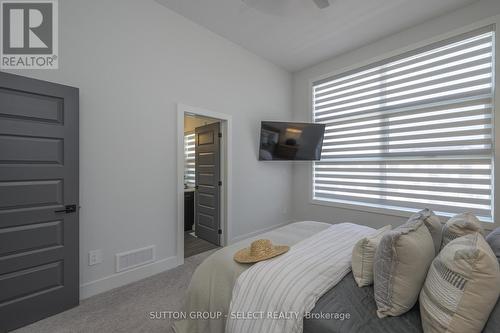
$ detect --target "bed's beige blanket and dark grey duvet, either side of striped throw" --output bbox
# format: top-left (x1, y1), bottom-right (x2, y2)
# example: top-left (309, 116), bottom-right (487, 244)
top-left (173, 221), bottom-right (500, 333)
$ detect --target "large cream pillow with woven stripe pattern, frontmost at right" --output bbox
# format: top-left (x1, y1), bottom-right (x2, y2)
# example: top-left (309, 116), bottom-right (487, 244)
top-left (420, 232), bottom-right (500, 333)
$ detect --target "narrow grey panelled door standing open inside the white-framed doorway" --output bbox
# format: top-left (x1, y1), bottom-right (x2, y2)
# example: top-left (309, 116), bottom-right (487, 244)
top-left (195, 123), bottom-right (222, 245)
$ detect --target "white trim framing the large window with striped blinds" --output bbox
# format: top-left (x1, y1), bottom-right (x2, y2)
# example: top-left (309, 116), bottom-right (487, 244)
top-left (308, 15), bottom-right (500, 230)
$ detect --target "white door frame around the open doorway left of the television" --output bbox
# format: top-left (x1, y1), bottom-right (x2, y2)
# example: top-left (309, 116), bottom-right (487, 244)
top-left (177, 103), bottom-right (232, 265)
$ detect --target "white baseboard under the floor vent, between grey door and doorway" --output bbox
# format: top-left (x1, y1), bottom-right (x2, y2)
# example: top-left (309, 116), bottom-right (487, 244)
top-left (80, 256), bottom-right (178, 300)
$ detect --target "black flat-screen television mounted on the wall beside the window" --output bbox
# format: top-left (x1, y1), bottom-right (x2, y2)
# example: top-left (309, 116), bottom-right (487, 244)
top-left (259, 121), bottom-right (325, 161)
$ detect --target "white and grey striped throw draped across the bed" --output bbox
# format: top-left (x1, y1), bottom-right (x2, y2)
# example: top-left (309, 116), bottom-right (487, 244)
top-left (226, 223), bottom-right (374, 333)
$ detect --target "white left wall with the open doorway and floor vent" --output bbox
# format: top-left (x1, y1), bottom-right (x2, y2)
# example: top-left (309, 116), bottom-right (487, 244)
top-left (3, 0), bottom-right (291, 297)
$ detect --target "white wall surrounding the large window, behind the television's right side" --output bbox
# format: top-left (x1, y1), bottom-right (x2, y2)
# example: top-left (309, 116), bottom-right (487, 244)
top-left (292, 0), bottom-right (500, 227)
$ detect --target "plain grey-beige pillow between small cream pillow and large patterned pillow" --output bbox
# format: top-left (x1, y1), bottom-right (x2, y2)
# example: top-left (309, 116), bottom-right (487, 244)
top-left (374, 214), bottom-right (435, 318)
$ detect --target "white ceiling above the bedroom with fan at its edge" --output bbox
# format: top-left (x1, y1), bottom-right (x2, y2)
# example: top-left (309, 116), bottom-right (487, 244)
top-left (156, 0), bottom-right (477, 71)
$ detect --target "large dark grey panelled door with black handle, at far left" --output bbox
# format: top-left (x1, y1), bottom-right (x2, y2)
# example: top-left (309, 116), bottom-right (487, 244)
top-left (0, 72), bottom-right (79, 332)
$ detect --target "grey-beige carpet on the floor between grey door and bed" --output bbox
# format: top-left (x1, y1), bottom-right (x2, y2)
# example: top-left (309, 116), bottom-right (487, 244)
top-left (14, 251), bottom-right (214, 333)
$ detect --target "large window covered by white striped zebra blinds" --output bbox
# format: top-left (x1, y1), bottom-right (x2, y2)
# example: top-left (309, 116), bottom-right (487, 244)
top-left (313, 27), bottom-right (494, 222)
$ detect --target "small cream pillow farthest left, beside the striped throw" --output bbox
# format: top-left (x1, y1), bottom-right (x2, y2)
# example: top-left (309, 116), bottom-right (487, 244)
top-left (352, 225), bottom-right (392, 287)
